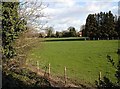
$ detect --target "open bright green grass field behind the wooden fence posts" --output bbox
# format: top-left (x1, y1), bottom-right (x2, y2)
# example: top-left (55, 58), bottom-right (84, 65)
top-left (27, 40), bottom-right (118, 84)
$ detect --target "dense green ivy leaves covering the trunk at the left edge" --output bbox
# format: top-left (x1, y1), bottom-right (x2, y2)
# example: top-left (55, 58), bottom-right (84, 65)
top-left (2, 2), bottom-right (26, 58)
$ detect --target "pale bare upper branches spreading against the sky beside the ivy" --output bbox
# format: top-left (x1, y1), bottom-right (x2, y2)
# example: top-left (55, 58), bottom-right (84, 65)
top-left (19, 0), bottom-right (48, 29)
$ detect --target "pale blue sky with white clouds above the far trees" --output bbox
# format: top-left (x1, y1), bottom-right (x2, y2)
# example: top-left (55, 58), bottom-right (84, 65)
top-left (22, 0), bottom-right (119, 31)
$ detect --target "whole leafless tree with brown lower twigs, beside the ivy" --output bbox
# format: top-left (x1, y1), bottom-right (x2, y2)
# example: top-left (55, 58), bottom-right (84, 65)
top-left (15, 0), bottom-right (48, 63)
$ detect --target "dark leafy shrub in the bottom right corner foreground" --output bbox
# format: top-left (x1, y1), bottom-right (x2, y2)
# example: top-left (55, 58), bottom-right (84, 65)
top-left (96, 49), bottom-right (120, 89)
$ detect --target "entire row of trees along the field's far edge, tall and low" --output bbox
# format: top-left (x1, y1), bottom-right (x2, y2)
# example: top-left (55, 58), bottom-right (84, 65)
top-left (39, 11), bottom-right (120, 40)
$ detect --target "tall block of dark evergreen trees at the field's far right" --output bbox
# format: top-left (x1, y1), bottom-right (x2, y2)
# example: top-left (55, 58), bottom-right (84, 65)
top-left (82, 11), bottom-right (120, 39)
